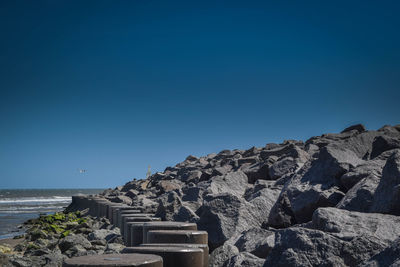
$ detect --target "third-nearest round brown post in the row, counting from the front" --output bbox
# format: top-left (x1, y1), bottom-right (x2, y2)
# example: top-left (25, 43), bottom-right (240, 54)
top-left (147, 230), bottom-right (208, 244)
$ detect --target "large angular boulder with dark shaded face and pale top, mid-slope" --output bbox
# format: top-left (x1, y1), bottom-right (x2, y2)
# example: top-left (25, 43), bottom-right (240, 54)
top-left (268, 145), bottom-right (363, 227)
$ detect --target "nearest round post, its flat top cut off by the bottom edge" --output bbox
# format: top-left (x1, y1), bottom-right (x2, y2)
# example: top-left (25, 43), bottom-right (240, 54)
top-left (63, 253), bottom-right (163, 267)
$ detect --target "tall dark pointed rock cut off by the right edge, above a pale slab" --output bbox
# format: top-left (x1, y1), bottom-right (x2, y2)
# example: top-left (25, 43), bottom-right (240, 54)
top-left (371, 149), bottom-right (400, 215)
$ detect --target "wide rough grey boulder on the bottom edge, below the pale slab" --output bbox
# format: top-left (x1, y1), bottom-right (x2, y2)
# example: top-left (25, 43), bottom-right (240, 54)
top-left (264, 227), bottom-right (386, 267)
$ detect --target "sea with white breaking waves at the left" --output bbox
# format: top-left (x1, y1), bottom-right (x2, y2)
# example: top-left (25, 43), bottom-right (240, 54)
top-left (0, 189), bottom-right (104, 239)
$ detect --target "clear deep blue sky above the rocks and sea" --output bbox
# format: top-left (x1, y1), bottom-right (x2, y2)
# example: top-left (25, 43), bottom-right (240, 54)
top-left (0, 0), bottom-right (400, 188)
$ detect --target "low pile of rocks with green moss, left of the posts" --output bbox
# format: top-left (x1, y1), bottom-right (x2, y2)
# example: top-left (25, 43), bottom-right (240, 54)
top-left (2, 212), bottom-right (125, 267)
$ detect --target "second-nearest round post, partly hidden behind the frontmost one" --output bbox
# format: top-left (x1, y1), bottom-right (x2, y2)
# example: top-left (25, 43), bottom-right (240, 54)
top-left (121, 246), bottom-right (204, 267)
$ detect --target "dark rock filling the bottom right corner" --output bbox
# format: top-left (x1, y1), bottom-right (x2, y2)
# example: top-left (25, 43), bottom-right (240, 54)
top-left (360, 238), bottom-right (400, 267)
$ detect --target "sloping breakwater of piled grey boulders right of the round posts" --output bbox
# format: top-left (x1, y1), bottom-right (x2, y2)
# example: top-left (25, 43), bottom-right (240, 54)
top-left (97, 125), bottom-right (400, 266)
